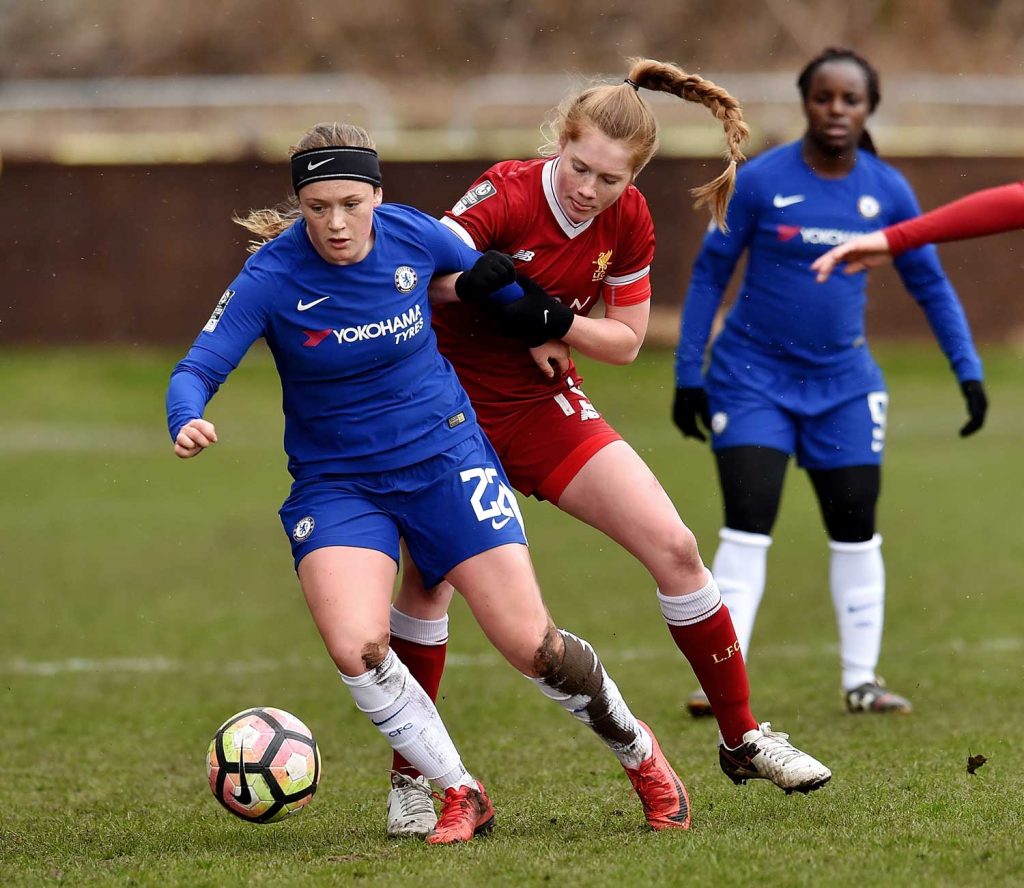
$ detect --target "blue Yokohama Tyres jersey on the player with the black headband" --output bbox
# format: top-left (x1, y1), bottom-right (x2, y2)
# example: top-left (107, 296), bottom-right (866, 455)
top-left (167, 204), bottom-right (499, 479)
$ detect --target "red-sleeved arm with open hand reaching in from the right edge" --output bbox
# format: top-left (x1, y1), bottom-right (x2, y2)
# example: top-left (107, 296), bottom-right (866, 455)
top-left (811, 181), bottom-right (1024, 284)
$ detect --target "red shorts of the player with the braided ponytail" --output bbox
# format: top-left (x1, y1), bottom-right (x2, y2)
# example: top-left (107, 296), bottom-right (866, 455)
top-left (474, 378), bottom-right (622, 503)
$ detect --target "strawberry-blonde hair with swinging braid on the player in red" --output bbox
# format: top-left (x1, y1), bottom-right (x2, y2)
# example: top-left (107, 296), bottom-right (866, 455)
top-left (541, 58), bottom-right (750, 231)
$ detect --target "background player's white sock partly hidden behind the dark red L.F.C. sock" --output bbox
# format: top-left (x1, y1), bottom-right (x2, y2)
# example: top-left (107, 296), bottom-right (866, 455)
top-left (711, 527), bottom-right (771, 661)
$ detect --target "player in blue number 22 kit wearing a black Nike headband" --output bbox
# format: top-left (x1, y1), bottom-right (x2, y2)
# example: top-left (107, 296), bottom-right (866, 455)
top-left (167, 124), bottom-right (690, 844)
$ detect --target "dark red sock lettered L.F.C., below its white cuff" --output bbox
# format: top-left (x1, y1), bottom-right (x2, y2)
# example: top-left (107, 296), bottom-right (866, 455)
top-left (669, 604), bottom-right (758, 748)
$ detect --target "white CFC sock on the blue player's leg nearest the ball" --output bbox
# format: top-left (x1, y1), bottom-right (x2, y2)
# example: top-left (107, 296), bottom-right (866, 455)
top-left (338, 650), bottom-right (477, 790)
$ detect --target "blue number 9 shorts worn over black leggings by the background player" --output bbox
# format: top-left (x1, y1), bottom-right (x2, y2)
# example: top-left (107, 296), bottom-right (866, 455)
top-left (707, 350), bottom-right (889, 469)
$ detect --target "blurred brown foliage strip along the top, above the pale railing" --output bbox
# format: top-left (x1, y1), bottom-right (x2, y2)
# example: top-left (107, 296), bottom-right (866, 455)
top-left (0, 0), bottom-right (1024, 78)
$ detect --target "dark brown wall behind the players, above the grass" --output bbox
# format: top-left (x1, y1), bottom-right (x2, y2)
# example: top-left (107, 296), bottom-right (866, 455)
top-left (0, 158), bottom-right (1024, 346)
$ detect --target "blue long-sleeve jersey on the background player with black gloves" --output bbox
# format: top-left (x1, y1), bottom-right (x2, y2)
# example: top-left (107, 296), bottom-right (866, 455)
top-left (676, 141), bottom-right (982, 387)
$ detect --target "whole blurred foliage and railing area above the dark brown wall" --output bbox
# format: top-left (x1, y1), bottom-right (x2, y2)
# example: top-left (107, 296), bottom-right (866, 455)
top-left (0, 0), bottom-right (1024, 163)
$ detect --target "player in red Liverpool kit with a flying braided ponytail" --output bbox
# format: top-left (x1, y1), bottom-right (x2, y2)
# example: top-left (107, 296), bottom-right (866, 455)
top-left (388, 59), bottom-right (830, 835)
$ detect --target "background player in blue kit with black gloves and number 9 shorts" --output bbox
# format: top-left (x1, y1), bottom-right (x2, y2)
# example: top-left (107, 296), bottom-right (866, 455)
top-left (673, 49), bottom-right (987, 715)
